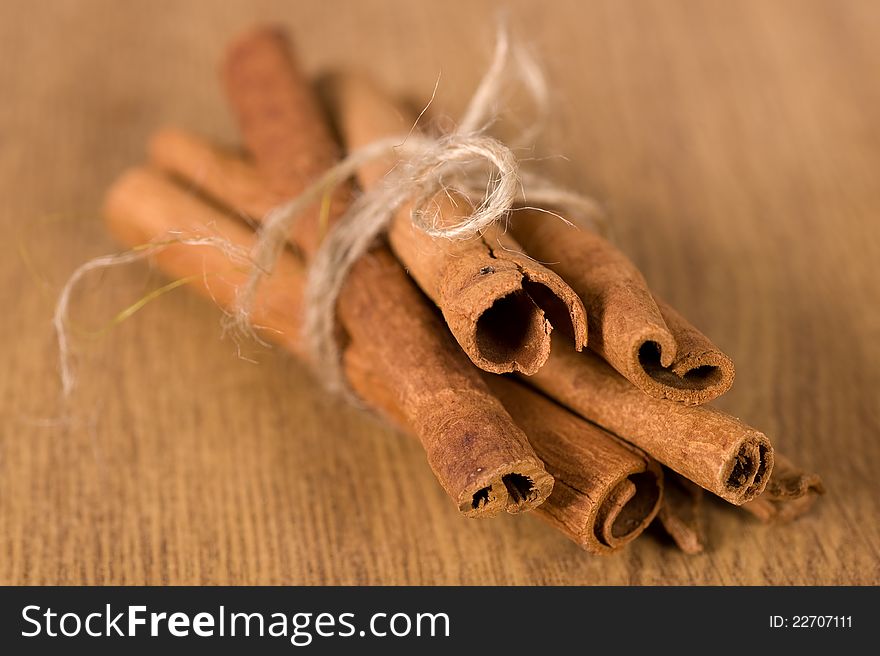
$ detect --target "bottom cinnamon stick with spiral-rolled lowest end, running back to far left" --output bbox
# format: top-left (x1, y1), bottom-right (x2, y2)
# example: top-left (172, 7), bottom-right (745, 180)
top-left (105, 169), bottom-right (663, 553)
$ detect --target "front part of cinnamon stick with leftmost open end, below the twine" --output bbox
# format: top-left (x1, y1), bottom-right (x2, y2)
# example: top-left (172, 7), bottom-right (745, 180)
top-left (338, 248), bottom-right (553, 515)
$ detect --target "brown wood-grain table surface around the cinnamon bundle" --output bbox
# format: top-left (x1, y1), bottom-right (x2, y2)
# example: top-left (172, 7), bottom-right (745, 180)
top-left (0, 0), bottom-right (880, 584)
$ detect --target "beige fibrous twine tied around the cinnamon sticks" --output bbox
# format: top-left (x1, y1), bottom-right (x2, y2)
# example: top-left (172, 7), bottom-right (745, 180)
top-left (232, 28), bottom-right (602, 394)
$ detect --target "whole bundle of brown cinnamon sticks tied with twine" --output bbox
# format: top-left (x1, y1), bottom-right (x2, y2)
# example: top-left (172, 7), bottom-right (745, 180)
top-left (99, 27), bottom-right (823, 553)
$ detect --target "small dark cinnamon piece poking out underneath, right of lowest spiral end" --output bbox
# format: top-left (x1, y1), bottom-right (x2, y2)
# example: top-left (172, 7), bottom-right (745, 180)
top-left (657, 468), bottom-right (706, 555)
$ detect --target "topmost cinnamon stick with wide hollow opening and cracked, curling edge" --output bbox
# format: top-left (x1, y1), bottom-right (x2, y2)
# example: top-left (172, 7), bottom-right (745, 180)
top-left (328, 76), bottom-right (587, 375)
